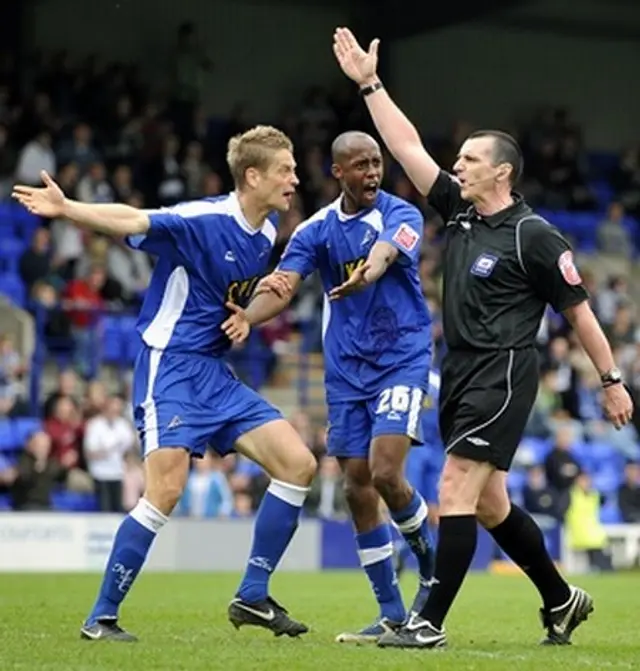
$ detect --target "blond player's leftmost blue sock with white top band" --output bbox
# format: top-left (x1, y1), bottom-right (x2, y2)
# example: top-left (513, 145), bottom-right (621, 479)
top-left (87, 499), bottom-right (168, 625)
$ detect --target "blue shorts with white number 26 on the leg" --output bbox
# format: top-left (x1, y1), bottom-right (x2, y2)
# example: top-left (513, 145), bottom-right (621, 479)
top-left (327, 385), bottom-right (425, 459)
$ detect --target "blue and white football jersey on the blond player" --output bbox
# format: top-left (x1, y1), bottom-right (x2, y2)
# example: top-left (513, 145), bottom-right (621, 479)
top-left (127, 193), bottom-right (276, 357)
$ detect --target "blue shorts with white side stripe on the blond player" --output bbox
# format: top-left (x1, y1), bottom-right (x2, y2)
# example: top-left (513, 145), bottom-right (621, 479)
top-left (133, 347), bottom-right (282, 457)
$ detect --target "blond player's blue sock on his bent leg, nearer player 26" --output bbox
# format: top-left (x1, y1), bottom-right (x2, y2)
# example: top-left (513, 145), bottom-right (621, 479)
top-left (236, 480), bottom-right (309, 603)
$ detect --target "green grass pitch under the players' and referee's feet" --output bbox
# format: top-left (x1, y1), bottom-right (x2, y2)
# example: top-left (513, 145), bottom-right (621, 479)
top-left (0, 572), bottom-right (640, 671)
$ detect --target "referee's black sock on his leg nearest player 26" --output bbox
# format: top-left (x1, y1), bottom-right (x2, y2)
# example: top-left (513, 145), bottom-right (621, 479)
top-left (420, 515), bottom-right (478, 629)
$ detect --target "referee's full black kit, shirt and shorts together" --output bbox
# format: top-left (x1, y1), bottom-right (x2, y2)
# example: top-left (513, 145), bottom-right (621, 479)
top-left (428, 172), bottom-right (588, 471)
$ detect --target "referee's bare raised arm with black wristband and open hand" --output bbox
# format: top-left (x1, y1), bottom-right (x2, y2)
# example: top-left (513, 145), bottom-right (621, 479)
top-left (333, 28), bottom-right (440, 196)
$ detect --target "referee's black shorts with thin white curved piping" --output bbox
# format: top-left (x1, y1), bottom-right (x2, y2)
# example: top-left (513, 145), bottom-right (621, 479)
top-left (440, 349), bottom-right (539, 471)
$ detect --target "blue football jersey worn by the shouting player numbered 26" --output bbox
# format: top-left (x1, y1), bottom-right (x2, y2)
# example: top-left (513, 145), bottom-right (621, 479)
top-left (278, 191), bottom-right (431, 400)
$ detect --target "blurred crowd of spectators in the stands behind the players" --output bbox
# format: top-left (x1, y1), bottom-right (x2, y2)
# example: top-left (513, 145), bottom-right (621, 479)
top-left (0, 39), bottom-right (640, 540)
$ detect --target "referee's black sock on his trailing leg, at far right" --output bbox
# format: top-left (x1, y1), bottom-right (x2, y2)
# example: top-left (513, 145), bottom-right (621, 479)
top-left (488, 504), bottom-right (571, 608)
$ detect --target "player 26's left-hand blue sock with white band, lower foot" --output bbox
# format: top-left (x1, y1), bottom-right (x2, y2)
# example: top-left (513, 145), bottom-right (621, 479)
top-left (356, 524), bottom-right (406, 622)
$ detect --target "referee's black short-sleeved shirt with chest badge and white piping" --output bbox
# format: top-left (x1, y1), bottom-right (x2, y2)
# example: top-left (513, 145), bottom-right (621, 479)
top-left (429, 172), bottom-right (588, 351)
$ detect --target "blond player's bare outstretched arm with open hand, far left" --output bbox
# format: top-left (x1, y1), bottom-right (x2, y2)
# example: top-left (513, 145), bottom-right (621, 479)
top-left (11, 170), bottom-right (149, 237)
